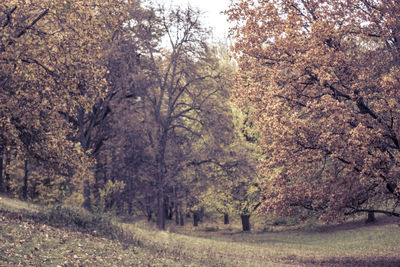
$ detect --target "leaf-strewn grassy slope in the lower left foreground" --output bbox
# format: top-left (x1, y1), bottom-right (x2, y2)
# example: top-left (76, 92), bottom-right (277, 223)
top-left (0, 197), bottom-right (182, 267)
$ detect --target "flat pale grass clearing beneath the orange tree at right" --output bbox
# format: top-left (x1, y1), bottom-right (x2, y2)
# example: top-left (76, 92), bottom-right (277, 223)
top-left (125, 218), bottom-right (400, 266)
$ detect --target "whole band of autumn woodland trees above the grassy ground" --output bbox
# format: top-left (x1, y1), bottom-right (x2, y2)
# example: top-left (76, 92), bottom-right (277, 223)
top-left (0, 0), bottom-right (400, 237)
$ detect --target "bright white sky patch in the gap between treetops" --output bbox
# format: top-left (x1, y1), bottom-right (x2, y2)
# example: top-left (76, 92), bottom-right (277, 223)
top-left (158, 0), bottom-right (231, 40)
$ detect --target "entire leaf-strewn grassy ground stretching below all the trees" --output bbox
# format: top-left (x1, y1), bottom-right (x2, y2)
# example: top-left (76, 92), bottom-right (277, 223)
top-left (0, 196), bottom-right (400, 267)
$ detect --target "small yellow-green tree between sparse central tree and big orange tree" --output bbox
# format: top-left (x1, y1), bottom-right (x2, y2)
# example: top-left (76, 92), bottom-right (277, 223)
top-left (200, 104), bottom-right (261, 231)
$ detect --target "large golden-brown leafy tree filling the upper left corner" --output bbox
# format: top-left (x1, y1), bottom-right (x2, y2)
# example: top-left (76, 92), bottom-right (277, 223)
top-left (0, 0), bottom-right (128, 196)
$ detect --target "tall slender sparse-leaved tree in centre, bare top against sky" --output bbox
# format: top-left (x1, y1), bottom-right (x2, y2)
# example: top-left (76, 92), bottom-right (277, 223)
top-left (134, 4), bottom-right (231, 229)
